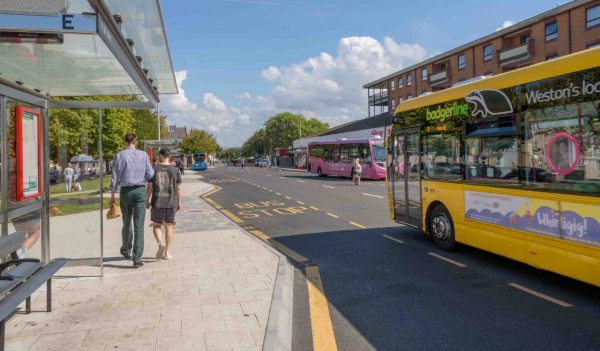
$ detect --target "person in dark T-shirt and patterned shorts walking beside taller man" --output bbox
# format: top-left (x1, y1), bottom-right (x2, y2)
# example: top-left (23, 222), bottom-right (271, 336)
top-left (146, 149), bottom-right (181, 260)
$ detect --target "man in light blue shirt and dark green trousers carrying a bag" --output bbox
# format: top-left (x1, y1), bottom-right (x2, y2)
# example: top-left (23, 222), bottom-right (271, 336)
top-left (110, 133), bottom-right (154, 268)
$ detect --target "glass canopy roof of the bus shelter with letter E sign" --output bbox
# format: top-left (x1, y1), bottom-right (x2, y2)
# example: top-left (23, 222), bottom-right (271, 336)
top-left (0, 0), bottom-right (177, 104)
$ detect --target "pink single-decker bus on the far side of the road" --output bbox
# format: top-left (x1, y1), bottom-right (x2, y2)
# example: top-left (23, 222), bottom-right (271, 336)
top-left (307, 138), bottom-right (385, 179)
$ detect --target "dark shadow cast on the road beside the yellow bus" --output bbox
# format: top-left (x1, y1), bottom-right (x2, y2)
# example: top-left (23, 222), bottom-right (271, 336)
top-left (276, 227), bottom-right (600, 350)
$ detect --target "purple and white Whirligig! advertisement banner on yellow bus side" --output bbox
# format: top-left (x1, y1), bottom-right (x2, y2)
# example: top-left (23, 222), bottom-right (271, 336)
top-left (464, 191), bottom-right (600, 246)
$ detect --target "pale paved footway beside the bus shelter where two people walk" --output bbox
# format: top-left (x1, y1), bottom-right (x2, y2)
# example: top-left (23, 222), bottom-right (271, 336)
top-left (6, 172), bottom-right (292, 351)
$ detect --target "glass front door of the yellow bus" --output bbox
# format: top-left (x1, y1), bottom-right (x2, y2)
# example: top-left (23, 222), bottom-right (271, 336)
top-left (389, 129), bottom-right (421, 227)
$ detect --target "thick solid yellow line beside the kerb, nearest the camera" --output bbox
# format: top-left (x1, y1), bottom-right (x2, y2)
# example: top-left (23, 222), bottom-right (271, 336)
top-left (306, 266), bottom-right (337, 351)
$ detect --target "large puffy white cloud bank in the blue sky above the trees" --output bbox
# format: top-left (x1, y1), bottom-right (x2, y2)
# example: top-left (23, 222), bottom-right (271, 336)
top-left (161, 36), bottom-right (427, 146)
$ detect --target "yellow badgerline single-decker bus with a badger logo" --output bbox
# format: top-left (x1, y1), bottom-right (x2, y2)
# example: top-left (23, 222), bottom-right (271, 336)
top-left (386, 48), bottom-right (600, 286)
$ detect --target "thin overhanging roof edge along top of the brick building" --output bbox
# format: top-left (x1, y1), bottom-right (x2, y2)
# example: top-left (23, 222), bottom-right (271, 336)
top-left (363, 0), bottom-right (591, 89)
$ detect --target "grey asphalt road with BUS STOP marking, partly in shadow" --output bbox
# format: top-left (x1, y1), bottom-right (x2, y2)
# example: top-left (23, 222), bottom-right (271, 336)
top-left (202, 167), bottom-right (600, 350)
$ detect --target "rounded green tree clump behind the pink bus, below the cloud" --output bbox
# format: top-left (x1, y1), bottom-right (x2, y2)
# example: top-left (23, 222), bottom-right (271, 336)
top-left (242, 112), bottom-right (329, 155)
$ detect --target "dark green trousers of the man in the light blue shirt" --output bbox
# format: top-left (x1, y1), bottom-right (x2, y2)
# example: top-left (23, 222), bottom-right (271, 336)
top-left (120, 185), bottom-right (146, 262)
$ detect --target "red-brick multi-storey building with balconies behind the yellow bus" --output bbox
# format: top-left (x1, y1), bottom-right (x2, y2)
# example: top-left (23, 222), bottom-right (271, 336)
top-left (363, 0), bottom-right (600, 117)
